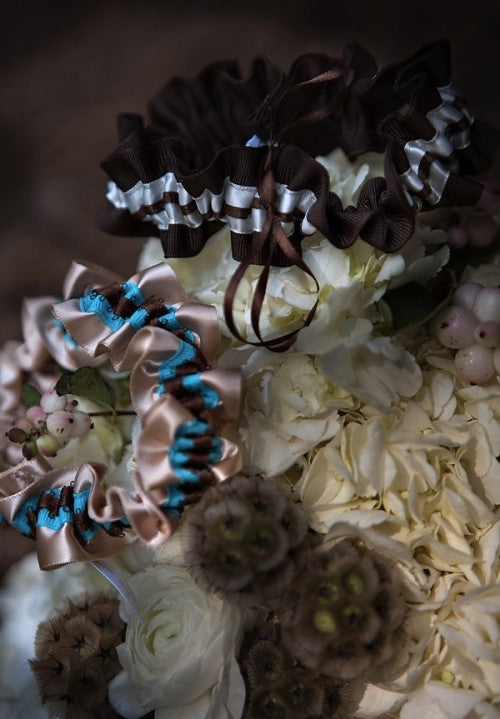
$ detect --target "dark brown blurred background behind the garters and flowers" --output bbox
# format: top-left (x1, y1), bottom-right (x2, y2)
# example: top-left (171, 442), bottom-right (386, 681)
top-left (0, 0), bottom-right (500, 571)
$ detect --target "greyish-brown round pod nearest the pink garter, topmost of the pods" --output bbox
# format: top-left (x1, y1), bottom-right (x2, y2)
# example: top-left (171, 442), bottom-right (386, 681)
top-left (181, 475), bottom-right (307, 605)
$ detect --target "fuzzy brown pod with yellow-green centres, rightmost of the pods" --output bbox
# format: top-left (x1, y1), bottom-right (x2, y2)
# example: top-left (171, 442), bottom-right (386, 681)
top-left (278, 539), bottom-right (406, 679)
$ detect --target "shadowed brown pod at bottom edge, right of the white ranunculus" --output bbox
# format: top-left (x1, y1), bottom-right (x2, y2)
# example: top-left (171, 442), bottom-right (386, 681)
top-left (239, 622), bottom-right (350, 719)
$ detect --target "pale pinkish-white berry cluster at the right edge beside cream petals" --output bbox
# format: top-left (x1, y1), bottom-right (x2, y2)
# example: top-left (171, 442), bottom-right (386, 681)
top-left (430, 282), bottom-right (500, 384)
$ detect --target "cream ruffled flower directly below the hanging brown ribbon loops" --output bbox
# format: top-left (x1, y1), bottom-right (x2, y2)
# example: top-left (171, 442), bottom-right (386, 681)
top-left (222, 349), bottom-right (353, 477)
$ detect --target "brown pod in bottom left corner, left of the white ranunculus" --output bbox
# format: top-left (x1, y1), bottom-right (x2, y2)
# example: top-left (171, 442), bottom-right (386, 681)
top-left (31, 592), bottom-right (125, 719)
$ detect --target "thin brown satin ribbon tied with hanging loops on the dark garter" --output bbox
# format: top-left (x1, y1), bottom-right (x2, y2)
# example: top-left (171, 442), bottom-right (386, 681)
top-left (224, 66), bottom-right (343, 352)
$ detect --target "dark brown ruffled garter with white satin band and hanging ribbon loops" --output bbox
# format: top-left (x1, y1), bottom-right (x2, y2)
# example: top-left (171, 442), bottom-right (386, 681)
top-left (98, 42), bottom-right (498, 351)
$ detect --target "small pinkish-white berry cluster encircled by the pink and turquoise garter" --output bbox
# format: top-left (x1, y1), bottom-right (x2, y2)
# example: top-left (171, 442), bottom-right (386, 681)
top-left (6, 389), bottom-right (93, 459)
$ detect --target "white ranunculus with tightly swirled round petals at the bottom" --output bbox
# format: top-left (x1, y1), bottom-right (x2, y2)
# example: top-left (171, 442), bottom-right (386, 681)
top-left (109, 565), bottom-right (244, 719)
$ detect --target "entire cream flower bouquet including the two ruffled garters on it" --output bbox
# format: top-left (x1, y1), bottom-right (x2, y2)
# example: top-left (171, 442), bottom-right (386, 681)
top-left (0, 42), bottom-right (500, 719)
